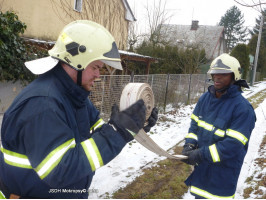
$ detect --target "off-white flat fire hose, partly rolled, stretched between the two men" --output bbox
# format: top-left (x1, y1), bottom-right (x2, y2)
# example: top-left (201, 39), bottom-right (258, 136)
top-left (120, 83), bottom-right (187, 160)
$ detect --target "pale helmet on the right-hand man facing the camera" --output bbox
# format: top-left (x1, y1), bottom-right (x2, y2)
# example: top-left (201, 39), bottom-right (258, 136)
top-left (207, 53), bottom-right (241, 81)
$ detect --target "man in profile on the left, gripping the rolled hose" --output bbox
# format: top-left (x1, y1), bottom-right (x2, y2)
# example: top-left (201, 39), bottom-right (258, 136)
top-left (0, 20), bottom-right (157, 199)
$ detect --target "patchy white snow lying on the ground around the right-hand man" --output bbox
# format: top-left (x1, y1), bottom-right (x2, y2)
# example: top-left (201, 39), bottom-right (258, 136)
top-left (89, 81), bottom-right (266, 199)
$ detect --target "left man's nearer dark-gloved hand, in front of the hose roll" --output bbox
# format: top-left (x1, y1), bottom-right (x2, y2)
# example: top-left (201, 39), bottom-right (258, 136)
top-left (109, 99), bottom-right (146, 142)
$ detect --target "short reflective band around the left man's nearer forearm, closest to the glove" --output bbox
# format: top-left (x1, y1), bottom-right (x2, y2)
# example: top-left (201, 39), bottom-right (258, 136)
top-left (81, 138), bottom-right (103, 171)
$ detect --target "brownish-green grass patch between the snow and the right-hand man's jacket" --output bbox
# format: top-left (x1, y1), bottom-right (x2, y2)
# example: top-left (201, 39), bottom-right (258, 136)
top-left (112, 146), bottom-right (192, 199)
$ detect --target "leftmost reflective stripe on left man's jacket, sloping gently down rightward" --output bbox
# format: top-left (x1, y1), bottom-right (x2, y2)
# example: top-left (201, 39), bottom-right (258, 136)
top-left (1, 146), bottom-right (32, 169)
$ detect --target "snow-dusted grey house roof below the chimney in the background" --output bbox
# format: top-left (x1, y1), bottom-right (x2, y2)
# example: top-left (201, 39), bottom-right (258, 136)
top-left (160, 24), bottom-right (224, 59)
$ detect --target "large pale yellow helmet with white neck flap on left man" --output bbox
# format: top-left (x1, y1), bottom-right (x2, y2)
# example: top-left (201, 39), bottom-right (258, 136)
top-left (25, 20), bottom-right (122, 74)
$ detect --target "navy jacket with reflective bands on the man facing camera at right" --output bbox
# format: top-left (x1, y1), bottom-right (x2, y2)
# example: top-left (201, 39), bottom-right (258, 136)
top-left (186, 85), bottom-right (256, 198)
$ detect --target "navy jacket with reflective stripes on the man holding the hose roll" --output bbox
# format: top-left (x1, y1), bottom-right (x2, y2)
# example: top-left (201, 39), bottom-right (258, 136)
top-left (0, 66), bottom-right (126, 198)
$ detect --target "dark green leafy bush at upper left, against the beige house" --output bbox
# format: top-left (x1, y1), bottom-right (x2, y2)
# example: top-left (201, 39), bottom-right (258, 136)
top-left (0, 11), bottom-right (47, 81)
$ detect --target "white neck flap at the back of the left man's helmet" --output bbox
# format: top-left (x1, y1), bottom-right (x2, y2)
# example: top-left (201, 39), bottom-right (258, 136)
top-left (25, 56), bottom-right (59, 75)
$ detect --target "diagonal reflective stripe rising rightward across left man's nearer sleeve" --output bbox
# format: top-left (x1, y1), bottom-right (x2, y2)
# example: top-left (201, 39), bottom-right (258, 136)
top-left (35, 139), bottom-right (76, 179)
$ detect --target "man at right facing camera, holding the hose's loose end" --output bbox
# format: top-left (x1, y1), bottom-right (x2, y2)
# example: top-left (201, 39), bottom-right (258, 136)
top-left (182, 54), bottom-right (256, 198)
